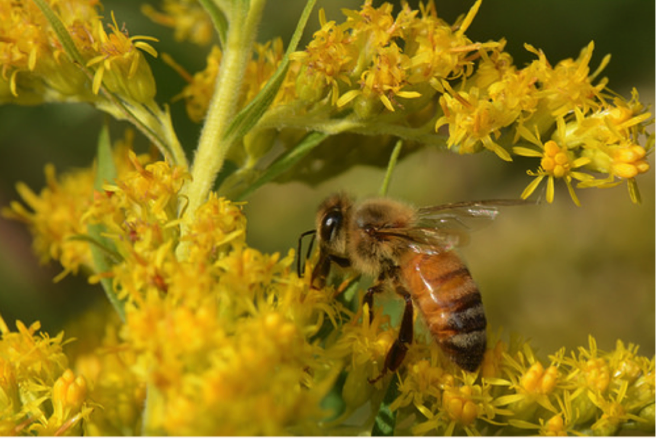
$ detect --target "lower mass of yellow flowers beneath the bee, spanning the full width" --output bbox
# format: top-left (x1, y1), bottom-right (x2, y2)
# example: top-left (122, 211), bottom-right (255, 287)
top-left (0, 142), bottom-right (656, 435)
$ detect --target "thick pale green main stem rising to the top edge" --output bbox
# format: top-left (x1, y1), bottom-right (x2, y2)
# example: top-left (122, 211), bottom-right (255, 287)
top-left (178, 0), bottom-right (266, 257)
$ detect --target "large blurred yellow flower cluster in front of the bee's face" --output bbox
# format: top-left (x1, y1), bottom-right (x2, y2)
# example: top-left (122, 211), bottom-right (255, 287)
top-left (2, 135), bottom-right (346, 435)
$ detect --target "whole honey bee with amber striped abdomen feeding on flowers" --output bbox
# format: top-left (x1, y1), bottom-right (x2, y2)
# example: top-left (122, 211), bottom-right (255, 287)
top-left (299, 193), bottom-right (526, 382)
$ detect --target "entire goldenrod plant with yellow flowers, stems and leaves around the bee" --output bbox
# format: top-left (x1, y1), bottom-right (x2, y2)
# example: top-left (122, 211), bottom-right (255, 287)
top-left (0, 0), bottom-right (656, 435)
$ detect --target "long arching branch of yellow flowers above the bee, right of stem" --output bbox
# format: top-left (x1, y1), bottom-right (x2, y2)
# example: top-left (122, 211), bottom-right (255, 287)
top-left (182, 0), bottom-right (651, 204)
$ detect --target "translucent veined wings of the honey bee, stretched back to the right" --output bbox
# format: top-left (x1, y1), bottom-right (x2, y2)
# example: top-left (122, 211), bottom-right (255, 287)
top-left (381, 200), bottom-right (533, 253)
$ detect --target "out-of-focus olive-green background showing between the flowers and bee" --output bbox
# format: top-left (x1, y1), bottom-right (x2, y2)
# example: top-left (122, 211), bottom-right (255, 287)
top-left (0, 0), bottom-right (656, 356)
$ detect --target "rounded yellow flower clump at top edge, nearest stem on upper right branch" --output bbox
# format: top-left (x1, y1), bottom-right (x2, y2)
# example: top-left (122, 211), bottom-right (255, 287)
top-left (293, 1), bottom-right (483, 118)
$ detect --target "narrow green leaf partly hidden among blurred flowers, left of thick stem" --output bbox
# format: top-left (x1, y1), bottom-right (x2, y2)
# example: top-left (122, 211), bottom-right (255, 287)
top-left (87, 124), bottom-right (125, 321)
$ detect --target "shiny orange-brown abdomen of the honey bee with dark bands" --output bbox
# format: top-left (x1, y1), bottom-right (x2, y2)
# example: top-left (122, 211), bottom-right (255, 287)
top-left (401, 251), bottom-right (487, 372)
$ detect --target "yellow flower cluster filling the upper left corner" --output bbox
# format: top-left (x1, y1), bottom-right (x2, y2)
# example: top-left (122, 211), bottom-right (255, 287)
top-left (0, 0), bottom-right (156, 105)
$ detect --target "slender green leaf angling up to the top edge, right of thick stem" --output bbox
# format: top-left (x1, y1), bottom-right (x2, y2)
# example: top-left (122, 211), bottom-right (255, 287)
top-left (224, 0), bottom-right (316, 144)
